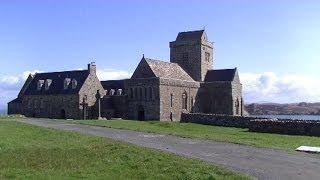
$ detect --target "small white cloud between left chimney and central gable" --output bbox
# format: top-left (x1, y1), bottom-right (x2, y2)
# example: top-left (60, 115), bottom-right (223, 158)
top-left (97, 69), bottom-right (132, 81)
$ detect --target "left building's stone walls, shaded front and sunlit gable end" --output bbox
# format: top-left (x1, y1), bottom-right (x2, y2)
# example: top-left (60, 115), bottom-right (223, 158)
top-left (22, 71), bottom-right (105, 119)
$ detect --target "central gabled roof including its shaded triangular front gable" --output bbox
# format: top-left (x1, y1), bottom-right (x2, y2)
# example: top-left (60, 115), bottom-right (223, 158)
top-left (132, 57), bottom-right (194, 81)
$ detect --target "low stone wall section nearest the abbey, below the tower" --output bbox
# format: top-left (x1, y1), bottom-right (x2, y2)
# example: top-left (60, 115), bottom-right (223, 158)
top-left (181, 113), bottom-right (257, 128)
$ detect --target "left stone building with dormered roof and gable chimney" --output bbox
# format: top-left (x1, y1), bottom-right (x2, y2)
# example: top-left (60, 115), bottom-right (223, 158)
top-left (8, 64), bottom-right (105, 119)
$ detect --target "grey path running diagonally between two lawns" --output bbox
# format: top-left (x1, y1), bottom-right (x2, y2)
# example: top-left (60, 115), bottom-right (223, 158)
top-left (21, 119), bottom-right (320, 180)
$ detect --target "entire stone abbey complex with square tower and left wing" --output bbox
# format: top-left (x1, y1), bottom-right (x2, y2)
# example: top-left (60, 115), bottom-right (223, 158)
top-left (8, 30), bottom-right (244, 121)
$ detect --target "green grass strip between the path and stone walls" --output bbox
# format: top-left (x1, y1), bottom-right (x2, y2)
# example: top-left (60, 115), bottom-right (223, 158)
top-left (71, 120), bottom-right (320, 152)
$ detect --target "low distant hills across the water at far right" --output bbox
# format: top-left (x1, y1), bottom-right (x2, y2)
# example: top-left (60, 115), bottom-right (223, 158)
top-left (245, 102), bottom-right (320, 115)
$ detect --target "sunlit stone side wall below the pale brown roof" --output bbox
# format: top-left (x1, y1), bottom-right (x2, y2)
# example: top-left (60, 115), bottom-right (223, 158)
top-left (160, 79), bottom-right (200, 121)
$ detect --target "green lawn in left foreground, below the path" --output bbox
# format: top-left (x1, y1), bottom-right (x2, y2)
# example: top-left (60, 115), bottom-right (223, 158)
top-left (0, 118), bottom-right (248, 179)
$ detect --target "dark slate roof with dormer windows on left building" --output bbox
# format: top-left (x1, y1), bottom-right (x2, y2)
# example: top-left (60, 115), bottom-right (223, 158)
top-left (25, 70), bottom-right (89, 95)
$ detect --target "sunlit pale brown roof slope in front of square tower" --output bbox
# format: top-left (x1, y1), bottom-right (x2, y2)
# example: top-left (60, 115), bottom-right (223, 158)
top-left (144, 58), bottom-right (194, 81)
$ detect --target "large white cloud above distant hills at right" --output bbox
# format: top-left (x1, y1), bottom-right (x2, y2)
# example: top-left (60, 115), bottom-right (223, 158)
top-left (240, 72), bottom-right (320, 103)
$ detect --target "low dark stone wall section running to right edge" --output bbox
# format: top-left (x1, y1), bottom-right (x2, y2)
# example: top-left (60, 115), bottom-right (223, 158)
top-left (249, 119), bottom-right (320, 136)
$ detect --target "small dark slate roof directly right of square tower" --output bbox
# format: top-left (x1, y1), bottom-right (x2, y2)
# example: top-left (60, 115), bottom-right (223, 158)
top-left (204, 68), bottom-right (237, 82)
